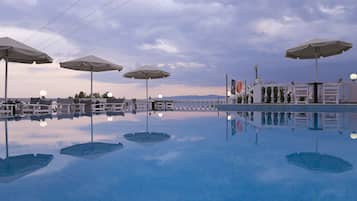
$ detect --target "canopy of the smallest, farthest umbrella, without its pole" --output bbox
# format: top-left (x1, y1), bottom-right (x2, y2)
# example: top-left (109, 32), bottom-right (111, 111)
top-left (124, 65), bottom-right (170, 80)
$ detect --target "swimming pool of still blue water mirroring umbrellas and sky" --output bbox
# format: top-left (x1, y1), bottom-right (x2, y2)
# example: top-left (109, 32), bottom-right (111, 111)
top-left (0, 112), bottom-right (357, 201)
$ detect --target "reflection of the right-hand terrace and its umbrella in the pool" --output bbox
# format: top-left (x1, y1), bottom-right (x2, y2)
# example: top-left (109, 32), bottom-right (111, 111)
top-left (226, 112), bottom-right (357, 173)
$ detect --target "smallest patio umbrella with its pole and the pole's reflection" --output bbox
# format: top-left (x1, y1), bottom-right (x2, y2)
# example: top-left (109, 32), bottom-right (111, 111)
top-left (124, 65), bottom-right (170, 131)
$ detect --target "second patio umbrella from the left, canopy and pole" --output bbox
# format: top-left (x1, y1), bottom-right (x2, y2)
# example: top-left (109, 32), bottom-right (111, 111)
top-left (60, 55), bottom-right (123, 101)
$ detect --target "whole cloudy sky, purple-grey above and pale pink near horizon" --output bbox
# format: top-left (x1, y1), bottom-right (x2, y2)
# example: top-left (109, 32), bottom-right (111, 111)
top-left (0, 0), bottom-right (357, 97)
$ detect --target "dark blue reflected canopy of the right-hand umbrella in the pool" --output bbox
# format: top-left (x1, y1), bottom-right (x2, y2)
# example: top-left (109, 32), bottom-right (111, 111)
top-left (286, 152), bottom-right (353, 173)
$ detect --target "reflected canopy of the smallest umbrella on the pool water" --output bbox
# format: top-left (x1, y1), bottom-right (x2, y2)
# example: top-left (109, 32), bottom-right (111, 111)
top-left (124, 132), bottom-right (170, 143)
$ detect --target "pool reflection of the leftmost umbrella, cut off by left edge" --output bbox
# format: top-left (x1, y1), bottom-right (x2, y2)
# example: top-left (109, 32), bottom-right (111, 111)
top-left (0, 121), bottom-right (53, 183)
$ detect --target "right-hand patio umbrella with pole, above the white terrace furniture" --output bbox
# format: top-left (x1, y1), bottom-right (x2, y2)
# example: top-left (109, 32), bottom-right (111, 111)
top-left (285, 39), bottom-right (352, 82)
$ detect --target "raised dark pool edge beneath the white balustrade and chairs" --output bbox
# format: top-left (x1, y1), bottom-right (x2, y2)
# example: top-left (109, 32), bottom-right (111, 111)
top-left (216, 104), bottom-right (357, 112)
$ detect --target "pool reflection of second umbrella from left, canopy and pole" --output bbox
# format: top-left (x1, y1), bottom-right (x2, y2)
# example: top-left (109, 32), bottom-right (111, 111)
top-left (60, 115), bottom-right (123, 159)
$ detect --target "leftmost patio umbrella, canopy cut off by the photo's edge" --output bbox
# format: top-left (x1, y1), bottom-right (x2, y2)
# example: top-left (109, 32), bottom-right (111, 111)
top-left (0, 37), bottom-right (52, 103)
